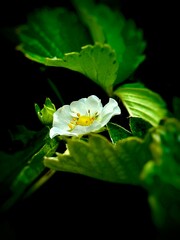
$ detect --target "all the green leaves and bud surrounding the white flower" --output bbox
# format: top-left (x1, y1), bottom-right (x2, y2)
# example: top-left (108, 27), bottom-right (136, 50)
top-left (0, 0), bottom-right (180, 236)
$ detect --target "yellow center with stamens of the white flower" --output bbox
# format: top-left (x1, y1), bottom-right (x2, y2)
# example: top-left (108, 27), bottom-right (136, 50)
top-left (68, 110), bottom-right (98, 130)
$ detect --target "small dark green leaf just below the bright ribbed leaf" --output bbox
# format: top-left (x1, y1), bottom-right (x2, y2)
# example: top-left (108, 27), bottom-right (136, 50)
top-left (129, 117), bottom-right (152, 138)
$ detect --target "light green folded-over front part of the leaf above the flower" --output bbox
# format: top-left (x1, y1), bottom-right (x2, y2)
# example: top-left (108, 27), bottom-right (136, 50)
top-left (21, 43), bottom-right (118, 95)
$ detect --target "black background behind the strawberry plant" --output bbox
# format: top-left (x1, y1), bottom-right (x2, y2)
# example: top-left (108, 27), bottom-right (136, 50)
top-left (0, 0), bottom-right (179, 240)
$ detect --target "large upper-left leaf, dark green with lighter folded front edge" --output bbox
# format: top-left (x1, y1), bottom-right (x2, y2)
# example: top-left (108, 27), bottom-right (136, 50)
top-left (17, 8), bottom-right (118, 95)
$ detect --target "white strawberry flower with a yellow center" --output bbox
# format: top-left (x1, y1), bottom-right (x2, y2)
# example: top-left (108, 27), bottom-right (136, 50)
top-left (50, 95), bottom-right (121, 138)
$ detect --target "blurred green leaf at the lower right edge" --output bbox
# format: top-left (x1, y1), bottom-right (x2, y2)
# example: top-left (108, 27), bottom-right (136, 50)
top-left (141, 118), bottom-right (180, 232)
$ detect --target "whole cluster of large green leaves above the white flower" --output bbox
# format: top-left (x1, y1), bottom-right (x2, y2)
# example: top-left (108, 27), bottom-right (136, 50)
top-left (17, 2), bottom-right (145, 91)
